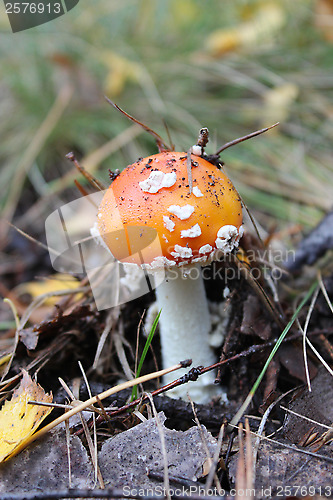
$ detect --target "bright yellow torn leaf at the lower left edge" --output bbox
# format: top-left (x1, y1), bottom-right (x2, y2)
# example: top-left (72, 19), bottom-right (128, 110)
top-left (0, 370), bottom-right (53, 462)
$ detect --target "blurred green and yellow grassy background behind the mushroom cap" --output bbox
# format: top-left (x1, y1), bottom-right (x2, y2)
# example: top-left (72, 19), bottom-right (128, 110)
top-left (0, 0), bottom-right (333, 242)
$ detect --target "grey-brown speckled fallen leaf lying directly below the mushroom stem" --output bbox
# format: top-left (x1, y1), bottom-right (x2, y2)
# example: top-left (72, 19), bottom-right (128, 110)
top-left (98, 412), bottom-right (217, 488)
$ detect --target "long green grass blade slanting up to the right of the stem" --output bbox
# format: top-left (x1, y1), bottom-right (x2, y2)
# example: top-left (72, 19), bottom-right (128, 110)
top-left (230, 281), bottom-right (318, 425)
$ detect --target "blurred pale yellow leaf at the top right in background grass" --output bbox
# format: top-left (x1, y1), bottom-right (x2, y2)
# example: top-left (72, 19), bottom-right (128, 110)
top-left (206, 2), bottom-right (286, 57)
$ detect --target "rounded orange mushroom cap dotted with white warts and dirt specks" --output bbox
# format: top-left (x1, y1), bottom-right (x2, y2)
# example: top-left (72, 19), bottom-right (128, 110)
top-left (97, 152), bottom-right (242, 267)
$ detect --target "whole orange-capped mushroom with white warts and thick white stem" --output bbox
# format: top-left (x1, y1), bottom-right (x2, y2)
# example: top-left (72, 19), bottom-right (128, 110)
top-left (97, 147), bottom-right (243, 403)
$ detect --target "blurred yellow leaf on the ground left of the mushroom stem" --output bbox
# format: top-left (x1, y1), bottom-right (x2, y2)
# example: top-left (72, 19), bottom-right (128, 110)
top-left (15, 273), bottom-right (80, 306)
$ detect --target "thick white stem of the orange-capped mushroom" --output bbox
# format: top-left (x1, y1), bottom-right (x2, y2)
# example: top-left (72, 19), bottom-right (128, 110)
top-left (156, 265), bottom-right (221, 403)
